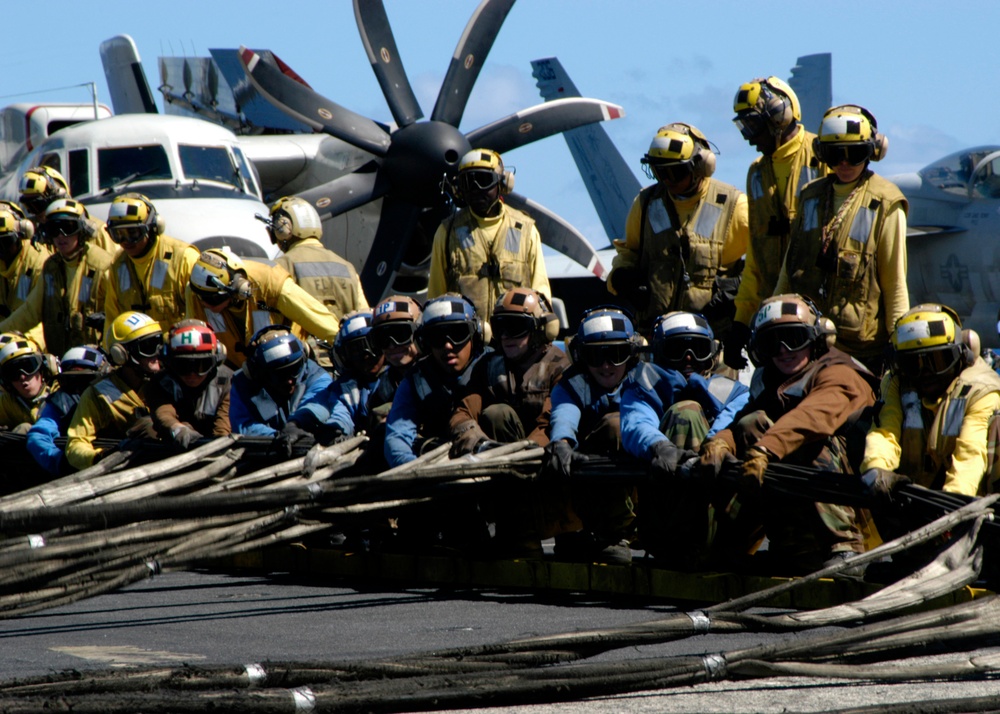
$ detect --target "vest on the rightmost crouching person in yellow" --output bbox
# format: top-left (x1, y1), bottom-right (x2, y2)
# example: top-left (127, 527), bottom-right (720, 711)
top-left (891, 357), bottom-right (1000, 495)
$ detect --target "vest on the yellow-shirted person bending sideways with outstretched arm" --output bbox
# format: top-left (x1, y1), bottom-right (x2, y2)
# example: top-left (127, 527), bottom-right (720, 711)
top-left (188, 260), bottom-right (291, 368)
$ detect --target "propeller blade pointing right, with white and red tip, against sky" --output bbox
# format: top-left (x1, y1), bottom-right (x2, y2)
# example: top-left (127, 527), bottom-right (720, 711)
top-left (465, 97), bottom-right (625, 154)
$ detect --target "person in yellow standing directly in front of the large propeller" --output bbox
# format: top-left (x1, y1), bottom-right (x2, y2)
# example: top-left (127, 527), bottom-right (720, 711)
top-left (427, 149), bottom-right (552, 322)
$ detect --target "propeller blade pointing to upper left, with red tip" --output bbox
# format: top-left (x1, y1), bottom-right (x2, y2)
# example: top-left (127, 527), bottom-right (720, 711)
top-left (239, 46), bottom-right (389, 156)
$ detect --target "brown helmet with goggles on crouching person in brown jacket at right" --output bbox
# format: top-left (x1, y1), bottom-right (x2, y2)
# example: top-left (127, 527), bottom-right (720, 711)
top-left (747, 294), bottom-right (837, 367)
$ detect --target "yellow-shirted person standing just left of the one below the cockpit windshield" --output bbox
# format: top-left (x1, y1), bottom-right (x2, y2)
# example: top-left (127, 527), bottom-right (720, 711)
top-left (0, 198), bottom-right (112, 354)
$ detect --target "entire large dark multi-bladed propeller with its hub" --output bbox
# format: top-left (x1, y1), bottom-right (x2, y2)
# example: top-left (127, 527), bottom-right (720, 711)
top-left (240, 0), bottom-right (624, 300)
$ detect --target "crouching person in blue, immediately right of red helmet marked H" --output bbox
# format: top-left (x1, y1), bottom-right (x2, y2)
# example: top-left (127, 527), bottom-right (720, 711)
top-left (229, 325), bottom-right (333, 455)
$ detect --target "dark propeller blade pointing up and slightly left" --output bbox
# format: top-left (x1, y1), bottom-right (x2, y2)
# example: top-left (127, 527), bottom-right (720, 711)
top-left (354, 0), bottom-right (424, 128)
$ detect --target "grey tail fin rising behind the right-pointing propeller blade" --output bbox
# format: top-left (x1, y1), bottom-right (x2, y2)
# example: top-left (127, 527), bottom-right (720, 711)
top-left (531, 57), bottom-right (642, 245)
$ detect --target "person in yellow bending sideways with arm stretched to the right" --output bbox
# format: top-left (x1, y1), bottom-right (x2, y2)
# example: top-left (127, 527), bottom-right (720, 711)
top-left (185, 248), bottom-right (340, 369)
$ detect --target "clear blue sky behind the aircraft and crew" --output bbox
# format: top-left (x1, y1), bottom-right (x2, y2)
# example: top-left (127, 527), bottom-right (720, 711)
top-left (0, 0), bottom-right (1000, 247)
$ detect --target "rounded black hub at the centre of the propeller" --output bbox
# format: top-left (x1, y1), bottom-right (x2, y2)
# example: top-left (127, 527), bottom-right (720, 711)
top-left (382, 121), bottom-right (472, 206)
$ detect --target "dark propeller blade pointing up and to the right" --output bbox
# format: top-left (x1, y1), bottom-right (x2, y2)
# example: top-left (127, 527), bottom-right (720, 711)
top-left (430, 0), bottom-right (514, 126)
